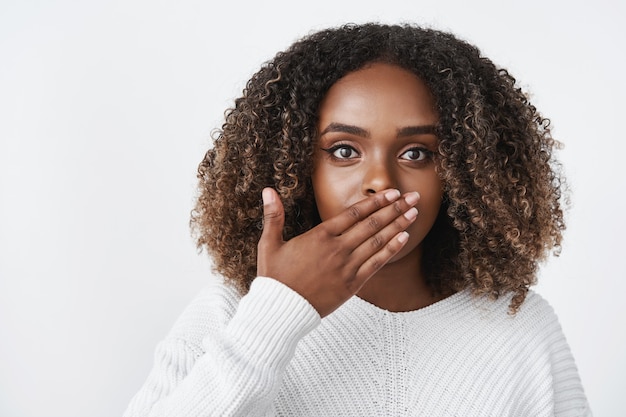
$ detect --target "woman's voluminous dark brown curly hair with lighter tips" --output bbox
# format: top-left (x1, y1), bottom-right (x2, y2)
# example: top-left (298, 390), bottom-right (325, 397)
top-left (191, 23), bottom-right (565, 313)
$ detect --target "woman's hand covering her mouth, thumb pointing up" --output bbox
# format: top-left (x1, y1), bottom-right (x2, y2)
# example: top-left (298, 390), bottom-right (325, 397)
top-left (257, 188), bottom-right (419, 317)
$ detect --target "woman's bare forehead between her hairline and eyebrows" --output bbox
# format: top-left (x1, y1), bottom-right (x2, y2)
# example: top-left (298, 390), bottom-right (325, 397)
top-left (319, 63), bottom-right (438, 125)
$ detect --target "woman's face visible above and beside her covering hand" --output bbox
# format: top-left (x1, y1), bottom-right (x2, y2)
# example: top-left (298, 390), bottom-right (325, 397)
top-left (312, 63), bottom-right (443, 261)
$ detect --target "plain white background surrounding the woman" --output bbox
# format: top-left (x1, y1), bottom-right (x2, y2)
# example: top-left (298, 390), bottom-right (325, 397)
top-left (0, 0), bottom-right (626, 417)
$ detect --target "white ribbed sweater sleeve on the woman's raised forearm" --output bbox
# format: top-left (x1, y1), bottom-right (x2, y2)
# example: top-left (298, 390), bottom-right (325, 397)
top-left (124, 277), bottom-right (320, 417)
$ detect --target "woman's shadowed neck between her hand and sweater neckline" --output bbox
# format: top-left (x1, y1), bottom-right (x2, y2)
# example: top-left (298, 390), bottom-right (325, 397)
top-left (357, 246), bottom-right (443, 312)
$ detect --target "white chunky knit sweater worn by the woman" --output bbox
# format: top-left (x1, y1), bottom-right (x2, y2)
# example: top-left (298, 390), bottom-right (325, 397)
top-left (125, 277), bottom-right (591, 417)
